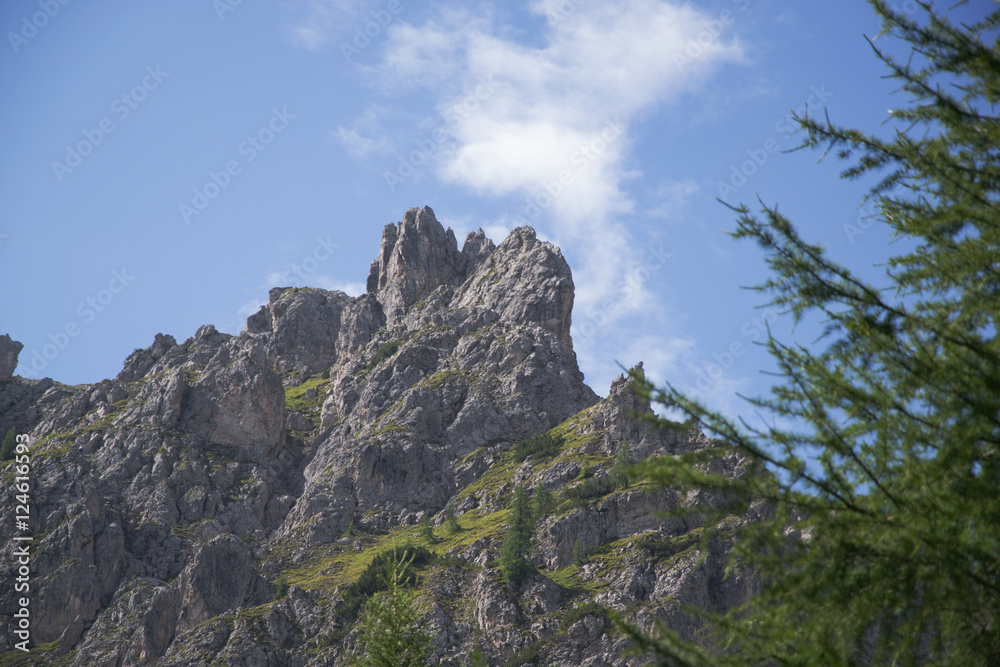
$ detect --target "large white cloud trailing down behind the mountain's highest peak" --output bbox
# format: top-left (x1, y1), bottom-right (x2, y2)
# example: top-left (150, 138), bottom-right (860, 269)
top-left (339, 0), bottom-right (743, 408)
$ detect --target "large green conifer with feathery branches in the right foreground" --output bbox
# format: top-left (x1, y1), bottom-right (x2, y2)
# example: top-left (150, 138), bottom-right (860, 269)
top-left (623, 0), bottom-right (1000, 666)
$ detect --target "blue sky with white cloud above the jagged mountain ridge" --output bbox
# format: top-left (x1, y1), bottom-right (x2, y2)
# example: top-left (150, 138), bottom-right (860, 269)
top-left (0, 0), bottom-right (973, 414)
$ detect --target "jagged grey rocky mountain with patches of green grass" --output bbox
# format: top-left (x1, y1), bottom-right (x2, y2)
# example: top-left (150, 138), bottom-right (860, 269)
top-left (0, 208), bottom-right (762, 667)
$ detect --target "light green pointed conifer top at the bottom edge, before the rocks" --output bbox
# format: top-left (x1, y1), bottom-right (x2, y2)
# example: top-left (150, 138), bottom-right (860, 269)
top-left (351, 554), bottom-right (433, 667)
